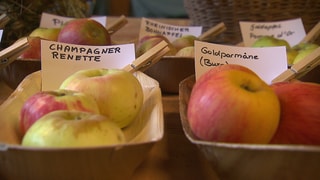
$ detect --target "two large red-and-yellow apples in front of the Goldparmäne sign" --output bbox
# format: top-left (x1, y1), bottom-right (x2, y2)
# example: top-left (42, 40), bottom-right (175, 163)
top-left (187, 64), bottom-right (320, 145)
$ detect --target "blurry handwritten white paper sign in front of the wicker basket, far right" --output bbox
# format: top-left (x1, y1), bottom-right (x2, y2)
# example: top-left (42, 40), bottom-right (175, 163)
top-left (240, 18), bottom-right (306, 47)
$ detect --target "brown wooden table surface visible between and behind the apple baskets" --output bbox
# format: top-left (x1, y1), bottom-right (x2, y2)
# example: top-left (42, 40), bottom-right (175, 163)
top-left (0, 18), bottom-right (218, 180)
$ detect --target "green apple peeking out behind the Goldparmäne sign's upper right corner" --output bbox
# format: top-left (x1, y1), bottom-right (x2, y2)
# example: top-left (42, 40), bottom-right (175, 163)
top-left (252, 36), bottom-right (297, 66)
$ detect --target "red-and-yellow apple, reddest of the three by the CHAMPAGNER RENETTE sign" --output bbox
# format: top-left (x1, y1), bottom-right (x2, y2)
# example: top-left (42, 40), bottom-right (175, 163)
top-left (20, 89), bottom-right (99, 134)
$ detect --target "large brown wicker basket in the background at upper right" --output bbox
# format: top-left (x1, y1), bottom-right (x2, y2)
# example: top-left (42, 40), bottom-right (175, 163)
top-left (184, 0), bottom-right (320, 44)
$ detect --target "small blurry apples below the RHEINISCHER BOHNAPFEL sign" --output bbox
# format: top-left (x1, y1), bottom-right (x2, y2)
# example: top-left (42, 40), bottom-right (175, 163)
top-left (136, 34), bottom-right (198, 57)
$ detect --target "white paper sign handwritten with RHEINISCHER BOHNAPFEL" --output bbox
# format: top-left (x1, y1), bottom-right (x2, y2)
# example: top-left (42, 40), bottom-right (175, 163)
top-left (139, 18), bottom-right (202, 42)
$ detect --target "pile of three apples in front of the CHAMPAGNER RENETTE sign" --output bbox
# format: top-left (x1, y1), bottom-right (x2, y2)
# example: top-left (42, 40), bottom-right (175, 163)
top-left (20, 69), bottom-right (144, 147)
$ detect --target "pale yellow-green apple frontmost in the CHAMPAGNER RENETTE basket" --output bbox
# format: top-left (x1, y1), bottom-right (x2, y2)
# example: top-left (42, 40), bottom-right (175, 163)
top-left (22, 110), bottom-right (126, 148)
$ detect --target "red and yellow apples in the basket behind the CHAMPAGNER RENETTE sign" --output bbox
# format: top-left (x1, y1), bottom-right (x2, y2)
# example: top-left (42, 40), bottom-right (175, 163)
top-left (18, 18), bottom-right (112, 60)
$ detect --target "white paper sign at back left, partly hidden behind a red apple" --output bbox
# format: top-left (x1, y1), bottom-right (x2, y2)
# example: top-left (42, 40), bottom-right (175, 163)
top-left (40, 13), bottom-right (107, 28)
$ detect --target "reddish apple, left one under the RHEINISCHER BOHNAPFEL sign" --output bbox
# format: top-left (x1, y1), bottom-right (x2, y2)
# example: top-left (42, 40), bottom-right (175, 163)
top-left (136, 34), bottom-right (177, 57)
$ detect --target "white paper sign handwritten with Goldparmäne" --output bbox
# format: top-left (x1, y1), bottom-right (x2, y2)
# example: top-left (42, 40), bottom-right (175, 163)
top-left (195, 41), bottom-right (287, 84)
